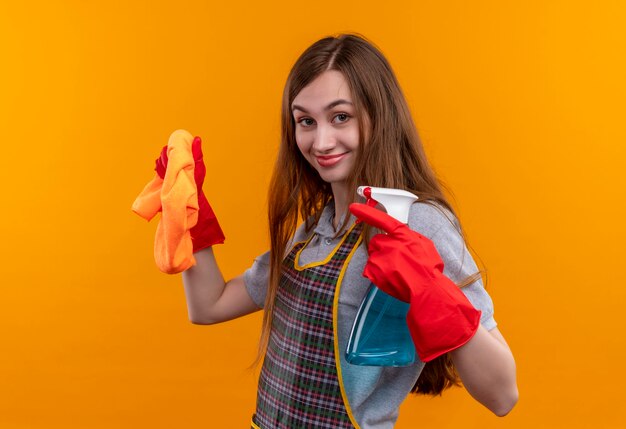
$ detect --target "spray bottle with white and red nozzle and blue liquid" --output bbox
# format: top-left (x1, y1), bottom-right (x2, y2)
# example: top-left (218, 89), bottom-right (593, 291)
top-left (346, 186), bottom-right (417, 366)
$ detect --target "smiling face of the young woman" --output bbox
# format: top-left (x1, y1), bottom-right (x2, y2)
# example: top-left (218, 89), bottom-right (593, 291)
top-left (291, 70), bottom-right (359, 192)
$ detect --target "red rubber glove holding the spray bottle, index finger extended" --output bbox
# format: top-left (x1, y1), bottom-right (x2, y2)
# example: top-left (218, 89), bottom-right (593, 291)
top-left (350, 204), bottom-right (480, 362)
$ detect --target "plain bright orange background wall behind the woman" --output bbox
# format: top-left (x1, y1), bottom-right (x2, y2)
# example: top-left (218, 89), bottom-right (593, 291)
top-left (0, 0), bottom-right (626, 429)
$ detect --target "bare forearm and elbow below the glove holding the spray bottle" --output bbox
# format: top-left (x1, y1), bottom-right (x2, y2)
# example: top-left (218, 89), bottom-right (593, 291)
top-left (450, 326), bottom-right (518, 416)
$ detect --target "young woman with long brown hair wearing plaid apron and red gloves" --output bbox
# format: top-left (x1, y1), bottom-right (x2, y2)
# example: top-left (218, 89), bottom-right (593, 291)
top-left (157, 35), bottom-right (517, 429)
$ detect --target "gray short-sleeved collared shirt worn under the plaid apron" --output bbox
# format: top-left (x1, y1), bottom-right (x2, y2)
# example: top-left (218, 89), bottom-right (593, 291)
top-left (244, 202), bottom-right (496, 429)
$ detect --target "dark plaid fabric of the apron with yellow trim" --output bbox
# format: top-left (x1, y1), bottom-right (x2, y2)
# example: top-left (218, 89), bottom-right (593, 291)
top-left (253, 224), bottom-right (362, 429)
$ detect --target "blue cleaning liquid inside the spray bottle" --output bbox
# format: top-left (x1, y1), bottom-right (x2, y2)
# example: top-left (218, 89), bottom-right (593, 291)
top-left (346, 284), bottom-right (415, 366)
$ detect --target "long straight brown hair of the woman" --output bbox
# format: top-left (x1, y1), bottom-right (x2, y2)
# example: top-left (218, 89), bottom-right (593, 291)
top-left (259, 34), bottom-right (482, 394)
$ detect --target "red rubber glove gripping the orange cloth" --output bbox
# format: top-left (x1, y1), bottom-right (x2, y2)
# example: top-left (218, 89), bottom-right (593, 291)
top-left (154, 137), bottom-right (225, 253)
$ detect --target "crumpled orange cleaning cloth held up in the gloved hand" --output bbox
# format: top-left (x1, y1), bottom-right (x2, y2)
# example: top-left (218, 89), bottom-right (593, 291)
top-left (132, 130), bottom-right (198, 274)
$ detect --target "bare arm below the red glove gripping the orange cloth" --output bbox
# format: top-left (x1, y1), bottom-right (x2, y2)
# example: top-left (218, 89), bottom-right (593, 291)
top-left (183, 247), bottom-right (260, 325)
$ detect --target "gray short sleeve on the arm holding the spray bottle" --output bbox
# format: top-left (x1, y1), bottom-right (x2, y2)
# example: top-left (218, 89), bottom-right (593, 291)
top-left (409, 203), bottom-right (497, 330)
